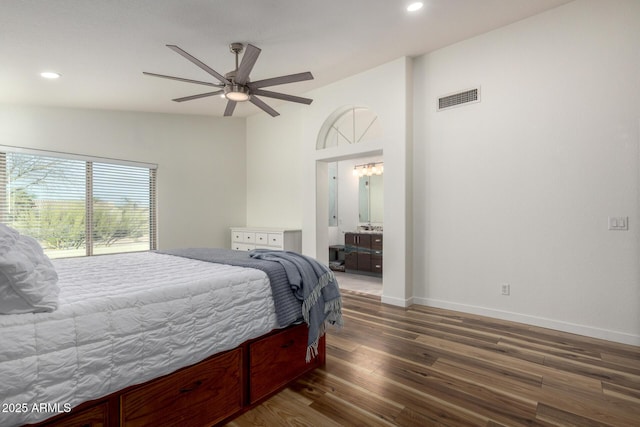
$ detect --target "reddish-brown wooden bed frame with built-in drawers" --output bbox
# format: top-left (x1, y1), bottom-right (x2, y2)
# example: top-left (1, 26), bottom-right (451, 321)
top-left (30, 324), bottom-right (326, 427)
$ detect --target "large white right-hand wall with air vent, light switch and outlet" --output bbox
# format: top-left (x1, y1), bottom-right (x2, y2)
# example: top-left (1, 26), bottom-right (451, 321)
top-left (414, 0), bottom-right (640, 344)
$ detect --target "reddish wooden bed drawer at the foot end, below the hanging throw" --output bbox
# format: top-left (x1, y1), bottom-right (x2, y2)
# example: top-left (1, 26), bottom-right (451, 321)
top-left (249, 324), bottom-right (318, 403)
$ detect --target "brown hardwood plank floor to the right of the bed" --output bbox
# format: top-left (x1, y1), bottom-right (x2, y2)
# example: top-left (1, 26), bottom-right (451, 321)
top-left (227, 291), bottom-right (640, 427)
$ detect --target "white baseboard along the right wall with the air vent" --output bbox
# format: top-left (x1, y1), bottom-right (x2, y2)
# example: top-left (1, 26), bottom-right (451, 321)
top-left (412, 297), bottom-right (640, 346)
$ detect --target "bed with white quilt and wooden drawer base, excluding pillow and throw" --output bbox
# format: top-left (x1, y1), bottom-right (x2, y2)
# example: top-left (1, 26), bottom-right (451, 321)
top-left (0, 227), bottom-right (342, 426)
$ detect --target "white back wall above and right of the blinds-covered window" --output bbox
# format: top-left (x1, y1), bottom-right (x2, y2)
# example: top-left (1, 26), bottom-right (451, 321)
top-left (0, 105), bottom-right (246, 248)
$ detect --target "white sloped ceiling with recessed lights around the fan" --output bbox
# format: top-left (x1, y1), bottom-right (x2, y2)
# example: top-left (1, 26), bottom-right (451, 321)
top-left (0, 0), bottom-right (569, 117)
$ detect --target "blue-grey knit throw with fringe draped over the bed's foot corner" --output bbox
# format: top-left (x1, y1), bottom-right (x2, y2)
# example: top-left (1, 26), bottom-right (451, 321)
top-left (249, 249), bottom-right (342, 362)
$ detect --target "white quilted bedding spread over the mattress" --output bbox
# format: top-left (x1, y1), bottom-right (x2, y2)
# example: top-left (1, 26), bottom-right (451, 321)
top-left (0, 252), bottom-right (277, 426)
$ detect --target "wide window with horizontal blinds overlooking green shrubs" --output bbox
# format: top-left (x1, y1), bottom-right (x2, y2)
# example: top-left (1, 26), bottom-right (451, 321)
top-left (0, 149), bottom-right (156, 258)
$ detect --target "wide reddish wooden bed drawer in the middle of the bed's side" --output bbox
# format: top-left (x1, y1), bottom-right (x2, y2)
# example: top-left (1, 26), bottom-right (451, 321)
top-left (121, 348), bottom-right (243, 426)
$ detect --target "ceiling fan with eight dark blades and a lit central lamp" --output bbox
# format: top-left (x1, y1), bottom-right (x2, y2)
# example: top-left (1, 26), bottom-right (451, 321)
top-left (142, 43), bottom-right (313, 117)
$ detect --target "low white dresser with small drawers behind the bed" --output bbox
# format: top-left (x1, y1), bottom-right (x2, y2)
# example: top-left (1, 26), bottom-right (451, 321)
top-left (231, 227), bottom-right (302, 252)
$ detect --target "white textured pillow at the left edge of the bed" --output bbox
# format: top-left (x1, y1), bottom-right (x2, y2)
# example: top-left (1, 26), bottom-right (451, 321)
top-left (0, 224), bottom-right (60, 314)
